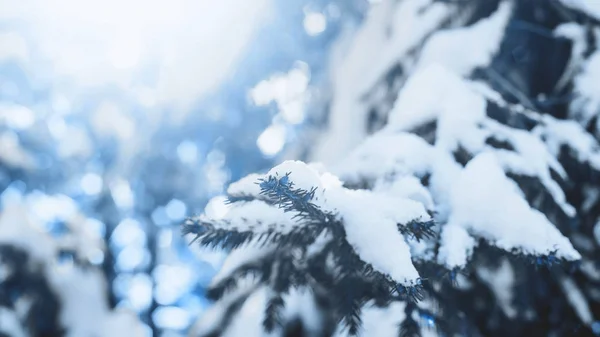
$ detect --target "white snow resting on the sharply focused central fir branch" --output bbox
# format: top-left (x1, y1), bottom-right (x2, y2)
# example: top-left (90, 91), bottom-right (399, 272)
top-left (209, 159), bottom-right (432, 285)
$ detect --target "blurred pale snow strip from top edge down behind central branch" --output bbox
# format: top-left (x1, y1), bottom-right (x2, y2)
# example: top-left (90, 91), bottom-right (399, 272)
top-left (312, 0), bottom-right (455, 164)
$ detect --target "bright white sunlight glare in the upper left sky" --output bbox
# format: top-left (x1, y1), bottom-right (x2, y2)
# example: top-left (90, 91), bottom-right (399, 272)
top-left (0, 0), bottom-right (271, 110)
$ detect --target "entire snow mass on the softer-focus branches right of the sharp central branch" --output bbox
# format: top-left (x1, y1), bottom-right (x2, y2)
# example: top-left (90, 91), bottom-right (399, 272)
top-left (334, 64), bottom-right (580, 267)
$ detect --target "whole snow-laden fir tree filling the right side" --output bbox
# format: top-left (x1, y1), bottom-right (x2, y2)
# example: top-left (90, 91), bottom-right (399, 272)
top-left (184, 0), bottom-right (600, 337)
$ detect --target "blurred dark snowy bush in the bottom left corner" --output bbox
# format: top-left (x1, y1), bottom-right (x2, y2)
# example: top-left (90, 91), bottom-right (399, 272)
top-left (0, 199), bottom-right (145, 337)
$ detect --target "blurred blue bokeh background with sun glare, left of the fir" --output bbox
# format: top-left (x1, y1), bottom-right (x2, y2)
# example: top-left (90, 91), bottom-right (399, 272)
top-left (0, 0), bottom-right (367, 337)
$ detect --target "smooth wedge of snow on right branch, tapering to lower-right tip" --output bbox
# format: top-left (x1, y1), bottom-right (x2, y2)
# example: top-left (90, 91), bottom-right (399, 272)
top-left (450, 153), bottom-right (581, 260)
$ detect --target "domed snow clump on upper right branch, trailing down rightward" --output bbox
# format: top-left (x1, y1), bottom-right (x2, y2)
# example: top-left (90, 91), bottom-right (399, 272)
top-left (384, 64), bottom-right (576, 216)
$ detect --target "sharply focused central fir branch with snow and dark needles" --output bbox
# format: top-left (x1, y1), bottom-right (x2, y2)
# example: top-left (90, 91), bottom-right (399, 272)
top-left (184, 161), bottom-right (433, 335)
